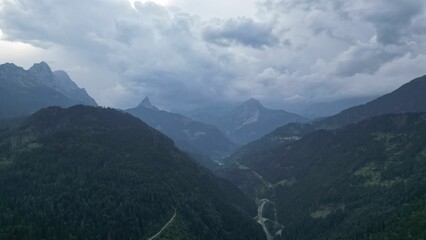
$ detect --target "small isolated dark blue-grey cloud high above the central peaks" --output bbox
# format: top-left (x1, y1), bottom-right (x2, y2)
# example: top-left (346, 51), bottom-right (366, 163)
top-left (203, 18), bottom-right (278, 48)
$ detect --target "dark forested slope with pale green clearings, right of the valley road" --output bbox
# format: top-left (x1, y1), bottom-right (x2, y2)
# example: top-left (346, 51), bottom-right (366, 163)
top-left (218, 113), bottom-right (426, 239)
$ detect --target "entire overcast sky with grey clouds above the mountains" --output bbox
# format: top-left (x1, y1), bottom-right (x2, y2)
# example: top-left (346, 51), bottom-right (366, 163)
top-left (0, 0), bottom-right (426, 109)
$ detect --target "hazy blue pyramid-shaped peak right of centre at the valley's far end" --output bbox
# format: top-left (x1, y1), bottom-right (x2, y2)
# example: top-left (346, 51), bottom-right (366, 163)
top-left (216, 99), bottom-right (307, 144)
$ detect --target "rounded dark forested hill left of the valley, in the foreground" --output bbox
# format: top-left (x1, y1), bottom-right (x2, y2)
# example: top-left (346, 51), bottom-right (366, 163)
top-left (0, 106), bottom-right (264, 239)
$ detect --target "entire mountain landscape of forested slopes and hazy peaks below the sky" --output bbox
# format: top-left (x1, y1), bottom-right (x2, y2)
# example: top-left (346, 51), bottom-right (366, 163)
top-left (0, 59), bottom-right (426, 240)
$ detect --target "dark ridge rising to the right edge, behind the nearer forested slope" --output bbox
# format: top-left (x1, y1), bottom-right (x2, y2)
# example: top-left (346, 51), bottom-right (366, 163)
top-left (228, 76), bottom-right (426, 161)
